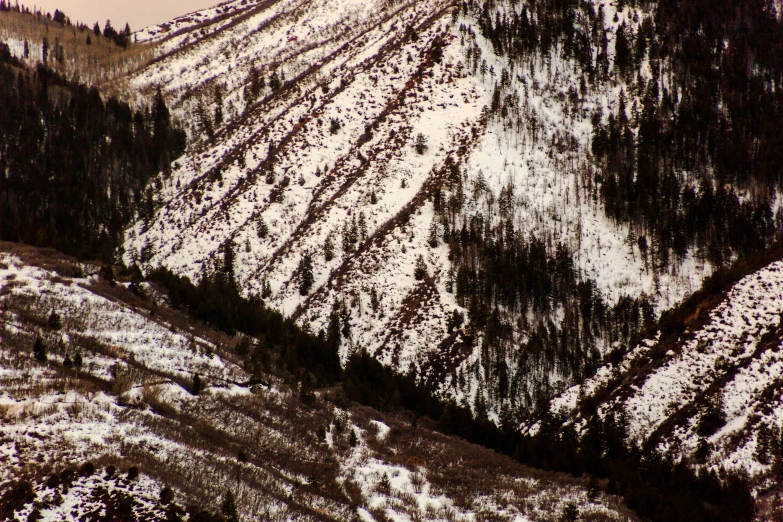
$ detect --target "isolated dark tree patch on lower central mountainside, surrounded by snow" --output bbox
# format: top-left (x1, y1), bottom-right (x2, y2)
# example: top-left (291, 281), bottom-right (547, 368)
top-left (438, 158), bottom-right (654, 415)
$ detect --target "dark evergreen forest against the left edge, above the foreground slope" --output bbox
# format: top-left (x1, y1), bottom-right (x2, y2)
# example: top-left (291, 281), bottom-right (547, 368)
top-left (0, 45), bottom-right (185, 259)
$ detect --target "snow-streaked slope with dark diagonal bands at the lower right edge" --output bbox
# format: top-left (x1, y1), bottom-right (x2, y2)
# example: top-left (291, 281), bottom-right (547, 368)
top-left (532, 250), bottom-right (783, 491)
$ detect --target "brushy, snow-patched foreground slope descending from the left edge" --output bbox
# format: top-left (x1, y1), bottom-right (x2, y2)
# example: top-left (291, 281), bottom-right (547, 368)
top-left (0, 244), bottom-right (633, 521)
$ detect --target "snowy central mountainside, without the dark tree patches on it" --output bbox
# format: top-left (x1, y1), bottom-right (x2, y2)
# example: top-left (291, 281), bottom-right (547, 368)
top-left (124, 0), bottom-right (712, 418)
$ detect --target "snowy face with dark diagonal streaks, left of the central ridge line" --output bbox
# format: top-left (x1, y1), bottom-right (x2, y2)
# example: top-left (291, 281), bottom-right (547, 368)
top-left (123, 3), bottom-right (486, 372)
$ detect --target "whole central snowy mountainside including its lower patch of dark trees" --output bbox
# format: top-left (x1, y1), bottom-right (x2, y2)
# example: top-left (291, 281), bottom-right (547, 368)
top-left (116, 0), bottom-right (781, 444)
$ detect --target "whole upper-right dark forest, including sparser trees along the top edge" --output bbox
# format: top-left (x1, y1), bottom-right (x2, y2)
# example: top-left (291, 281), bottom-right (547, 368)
top-left (472, 0), bottom-right (783, 269)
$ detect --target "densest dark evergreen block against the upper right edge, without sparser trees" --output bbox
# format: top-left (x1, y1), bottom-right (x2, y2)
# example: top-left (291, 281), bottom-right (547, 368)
top-left (593, 0), bottom-right (783, 266)
